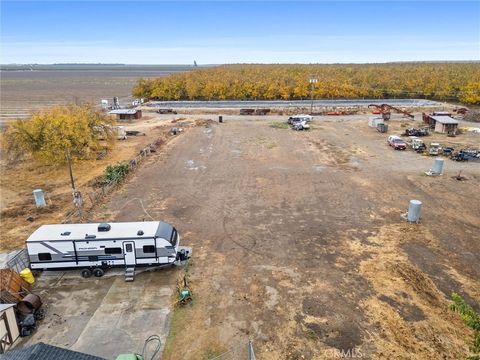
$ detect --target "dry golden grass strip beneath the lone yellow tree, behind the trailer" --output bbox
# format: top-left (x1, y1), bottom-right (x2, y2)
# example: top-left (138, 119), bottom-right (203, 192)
top-left (0, 119), bottom-right (172, 251)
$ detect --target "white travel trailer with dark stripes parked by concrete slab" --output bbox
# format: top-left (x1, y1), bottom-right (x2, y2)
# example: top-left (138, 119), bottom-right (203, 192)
top-left (27, 221), bottom-right (191, 280)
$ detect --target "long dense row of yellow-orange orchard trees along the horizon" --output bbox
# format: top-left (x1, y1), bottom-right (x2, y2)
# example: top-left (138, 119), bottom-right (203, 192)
top-left (133, 63), bottom-right (480, 104)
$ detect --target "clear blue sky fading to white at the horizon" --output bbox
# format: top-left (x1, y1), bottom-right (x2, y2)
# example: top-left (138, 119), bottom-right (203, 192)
top-left (0, 0), bottom-right (480, 65)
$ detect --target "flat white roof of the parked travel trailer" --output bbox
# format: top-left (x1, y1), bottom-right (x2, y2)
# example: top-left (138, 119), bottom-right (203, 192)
top-left (27, 221), bottom-right (173, 243)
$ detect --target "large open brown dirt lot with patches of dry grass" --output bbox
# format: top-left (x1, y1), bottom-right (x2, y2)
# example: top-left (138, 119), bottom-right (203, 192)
top-left (95, 118), bottom-right (480, 359)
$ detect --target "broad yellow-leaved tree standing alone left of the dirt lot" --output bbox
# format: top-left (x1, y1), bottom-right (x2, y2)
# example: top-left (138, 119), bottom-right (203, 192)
top-left (2, 104), bottom-right (116, 164)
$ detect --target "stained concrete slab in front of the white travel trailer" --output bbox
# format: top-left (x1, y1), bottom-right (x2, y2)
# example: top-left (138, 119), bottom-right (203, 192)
top-left (19, 269), bottom-right (177, 359)
